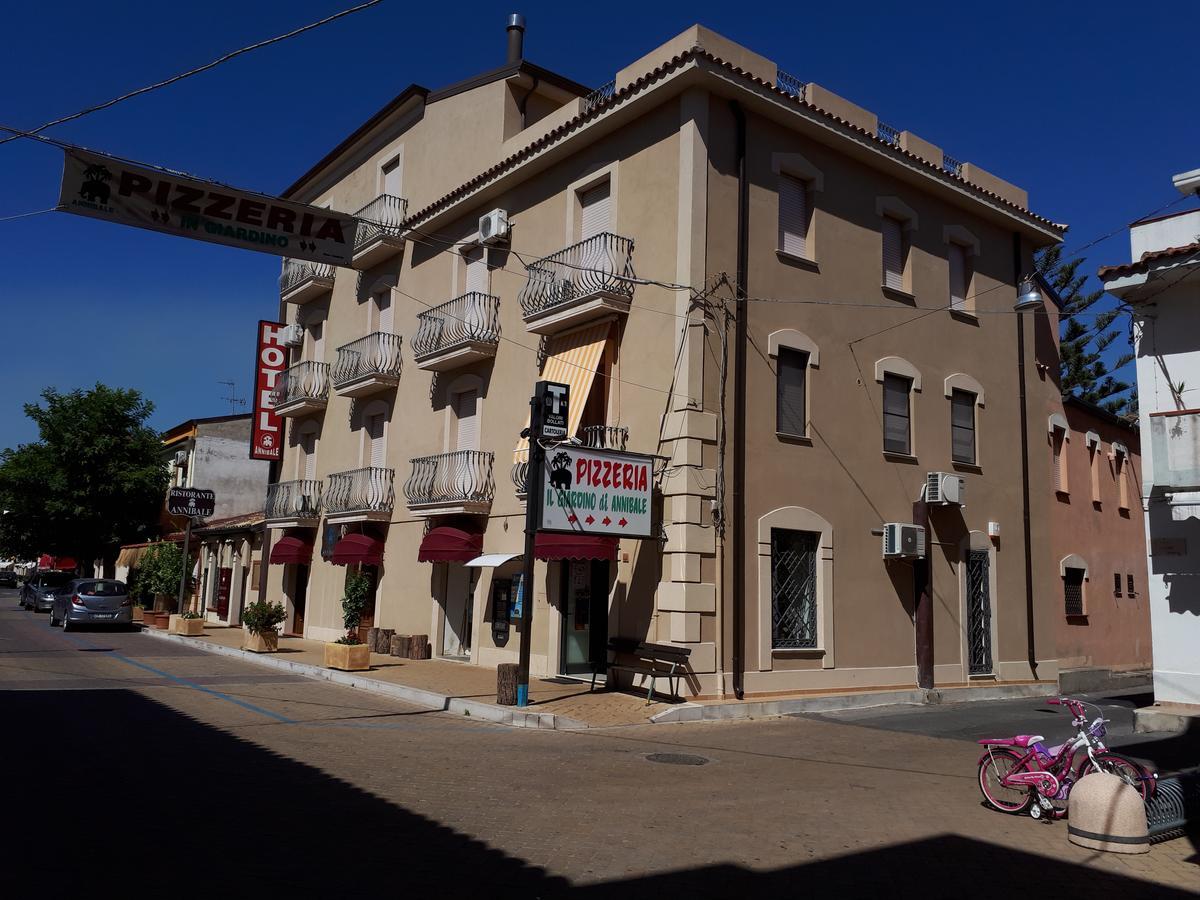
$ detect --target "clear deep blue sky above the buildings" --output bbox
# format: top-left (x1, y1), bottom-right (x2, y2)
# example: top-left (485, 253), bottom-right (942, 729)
top-left (0, 0), bottom-right (1200, 448)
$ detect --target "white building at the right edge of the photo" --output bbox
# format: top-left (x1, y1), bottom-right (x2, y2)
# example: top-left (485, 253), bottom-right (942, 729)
top-left (1099, 170), bottom-right (1200, 713)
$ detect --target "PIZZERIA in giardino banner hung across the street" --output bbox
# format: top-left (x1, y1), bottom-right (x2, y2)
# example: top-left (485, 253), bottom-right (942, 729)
top-left (59, 150), bottom-right (356, 266)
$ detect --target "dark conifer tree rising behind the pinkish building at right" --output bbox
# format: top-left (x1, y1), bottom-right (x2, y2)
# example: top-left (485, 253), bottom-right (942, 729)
top-left (1037, 246), bottom-right (1136, 415)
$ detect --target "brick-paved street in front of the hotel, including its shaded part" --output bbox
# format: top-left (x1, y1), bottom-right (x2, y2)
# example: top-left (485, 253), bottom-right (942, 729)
top-left (0, 590), bottom-right (1200, 898)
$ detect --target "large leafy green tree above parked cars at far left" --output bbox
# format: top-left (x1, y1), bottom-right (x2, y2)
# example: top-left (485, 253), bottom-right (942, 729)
top-left (0, 384), bottom-right (167, 560)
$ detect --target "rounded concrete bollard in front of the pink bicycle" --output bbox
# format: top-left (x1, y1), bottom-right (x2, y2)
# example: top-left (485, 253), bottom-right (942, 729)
top-left (1067, 772), bottom-right (1150, 853)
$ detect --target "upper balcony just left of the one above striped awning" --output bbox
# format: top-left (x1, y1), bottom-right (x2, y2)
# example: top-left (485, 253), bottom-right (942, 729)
top-left (413, 293), bottom-right (500, 372)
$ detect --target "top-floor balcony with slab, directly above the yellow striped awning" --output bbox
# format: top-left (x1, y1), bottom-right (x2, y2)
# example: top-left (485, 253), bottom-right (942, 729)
top-left (520, 233), bottom-right (634, 335)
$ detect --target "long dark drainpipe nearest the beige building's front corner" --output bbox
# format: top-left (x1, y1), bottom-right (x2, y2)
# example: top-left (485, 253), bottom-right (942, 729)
top-left (730, 101), bottom-right (750, 700)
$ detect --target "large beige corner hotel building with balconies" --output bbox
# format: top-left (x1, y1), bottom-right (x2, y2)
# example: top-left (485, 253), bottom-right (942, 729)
top-left (266, 19), bottom-right (1062, 696)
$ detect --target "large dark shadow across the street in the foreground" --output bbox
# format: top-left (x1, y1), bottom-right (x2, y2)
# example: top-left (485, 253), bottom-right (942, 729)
top-left (0, 690), bottom-right (1200, 900)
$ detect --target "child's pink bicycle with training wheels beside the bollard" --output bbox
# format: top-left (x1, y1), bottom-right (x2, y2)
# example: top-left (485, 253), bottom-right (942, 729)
top-left (977, 697), bottom-right (1154, 818)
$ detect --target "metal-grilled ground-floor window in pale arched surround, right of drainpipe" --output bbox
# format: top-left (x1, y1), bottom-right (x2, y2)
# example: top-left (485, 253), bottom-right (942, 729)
top-left (770, 528), bottom-right (820, 649)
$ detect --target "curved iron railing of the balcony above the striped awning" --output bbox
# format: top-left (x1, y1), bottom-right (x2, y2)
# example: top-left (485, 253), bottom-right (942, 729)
top-left (520, 232), bottom-right (634, 318)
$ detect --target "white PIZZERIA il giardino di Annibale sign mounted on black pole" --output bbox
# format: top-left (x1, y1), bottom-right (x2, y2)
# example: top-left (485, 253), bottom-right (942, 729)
top-left (540, 444), bottom-right (655, 538)
